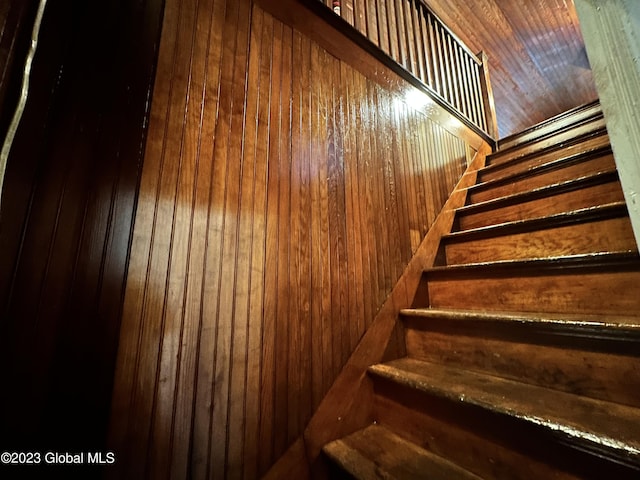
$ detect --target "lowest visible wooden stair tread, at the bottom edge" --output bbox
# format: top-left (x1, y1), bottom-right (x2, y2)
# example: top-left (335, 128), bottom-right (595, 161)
top-left (323, 424), bottom-right (480, 480)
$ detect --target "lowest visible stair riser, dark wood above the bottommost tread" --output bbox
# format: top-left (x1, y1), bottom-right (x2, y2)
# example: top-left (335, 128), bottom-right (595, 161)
top-left (374, 380), bottom-right (633, 480)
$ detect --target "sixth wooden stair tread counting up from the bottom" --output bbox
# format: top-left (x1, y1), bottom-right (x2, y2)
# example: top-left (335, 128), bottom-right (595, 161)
top-left (456, 169), bottom-right (618, 214)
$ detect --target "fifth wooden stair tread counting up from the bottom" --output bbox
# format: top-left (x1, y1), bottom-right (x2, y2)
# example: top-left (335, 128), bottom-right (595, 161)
top-left (442, 202), bottom-right (628, 243)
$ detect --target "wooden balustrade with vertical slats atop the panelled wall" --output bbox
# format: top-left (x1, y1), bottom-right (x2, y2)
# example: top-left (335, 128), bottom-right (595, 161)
top-left (319, 0), bottom-right (498, 139)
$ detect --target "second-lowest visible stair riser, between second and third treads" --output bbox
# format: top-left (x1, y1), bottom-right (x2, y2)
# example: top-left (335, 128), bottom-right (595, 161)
top-left (404, 318), bottom-right (640, 407)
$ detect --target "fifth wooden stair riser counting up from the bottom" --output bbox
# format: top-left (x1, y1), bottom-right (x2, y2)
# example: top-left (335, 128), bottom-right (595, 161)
top-left (454, 177), bottom-right (624, 231)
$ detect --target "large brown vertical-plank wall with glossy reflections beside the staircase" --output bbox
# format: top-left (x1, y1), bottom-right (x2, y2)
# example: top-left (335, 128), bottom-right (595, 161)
top-left (111, 0), bottom-right (473, 479)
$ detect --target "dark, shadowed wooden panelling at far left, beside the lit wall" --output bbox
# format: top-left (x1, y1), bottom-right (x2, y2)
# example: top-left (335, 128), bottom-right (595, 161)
top-left (0, 0), bottom-right (163, 454)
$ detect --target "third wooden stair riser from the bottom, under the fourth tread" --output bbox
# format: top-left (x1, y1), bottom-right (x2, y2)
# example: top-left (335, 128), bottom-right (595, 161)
top-left (427, 252), bottom-right (640, 315)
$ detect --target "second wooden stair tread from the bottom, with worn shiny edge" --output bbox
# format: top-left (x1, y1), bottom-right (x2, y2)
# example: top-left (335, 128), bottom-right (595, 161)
top-left (369, 358), bottom-right (640, 465)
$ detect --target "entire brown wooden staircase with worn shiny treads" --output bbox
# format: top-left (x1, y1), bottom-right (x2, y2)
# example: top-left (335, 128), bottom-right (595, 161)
top-left (323, 104), bottom-right (640, 479)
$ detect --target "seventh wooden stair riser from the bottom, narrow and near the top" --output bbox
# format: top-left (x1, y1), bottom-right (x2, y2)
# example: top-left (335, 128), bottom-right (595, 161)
top-left (478, 132), bottom-right (610, 182)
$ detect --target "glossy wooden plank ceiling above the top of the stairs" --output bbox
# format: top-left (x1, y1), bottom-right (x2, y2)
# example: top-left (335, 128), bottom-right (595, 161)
top-left (426, 0), bottom-right (597, 137)
